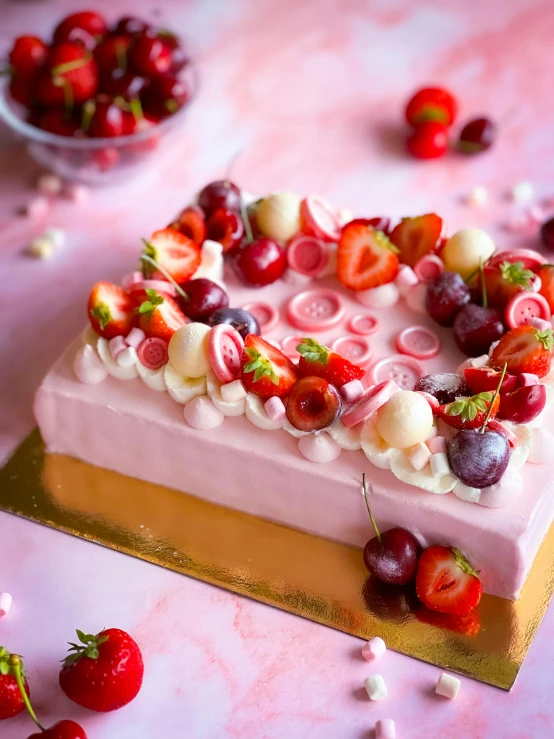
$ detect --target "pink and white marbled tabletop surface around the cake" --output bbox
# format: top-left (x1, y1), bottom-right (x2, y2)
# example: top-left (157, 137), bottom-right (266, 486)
top-left (0, 0), bottom-right (554, 739)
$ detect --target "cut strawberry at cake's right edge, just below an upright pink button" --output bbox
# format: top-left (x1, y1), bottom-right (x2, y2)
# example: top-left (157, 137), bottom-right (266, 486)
top-left (490, 325), bottom-right (554, 377)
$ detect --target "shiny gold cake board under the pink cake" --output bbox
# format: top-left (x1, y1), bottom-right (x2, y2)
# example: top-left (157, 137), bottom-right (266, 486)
top-left (0, 430), bottom-right (554, 690)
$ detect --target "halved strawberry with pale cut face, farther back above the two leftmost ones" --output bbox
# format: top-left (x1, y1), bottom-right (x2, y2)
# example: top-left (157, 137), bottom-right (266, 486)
top-left (142, 228), bottom-right (200, 282)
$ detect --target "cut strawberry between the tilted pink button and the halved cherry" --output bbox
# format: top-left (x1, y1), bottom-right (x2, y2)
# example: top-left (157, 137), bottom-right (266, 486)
top-left (238, 334), bottom-right (298, 400)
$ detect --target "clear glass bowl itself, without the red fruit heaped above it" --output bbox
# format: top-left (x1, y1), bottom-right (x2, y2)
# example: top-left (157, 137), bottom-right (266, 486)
top-left (0, 68), bottom-right (197, 185)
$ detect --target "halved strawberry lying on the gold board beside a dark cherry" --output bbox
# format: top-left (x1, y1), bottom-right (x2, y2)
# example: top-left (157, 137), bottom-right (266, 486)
top-left (416, 546), bottom-right (483, 616)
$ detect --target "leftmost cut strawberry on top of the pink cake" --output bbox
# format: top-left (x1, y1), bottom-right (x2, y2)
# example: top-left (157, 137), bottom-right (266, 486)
top-left (87, 282), bottom-right (135, 339)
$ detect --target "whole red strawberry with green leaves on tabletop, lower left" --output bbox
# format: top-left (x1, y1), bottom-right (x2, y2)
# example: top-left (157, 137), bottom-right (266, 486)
top-left (60, 629), bottom-right (144, 712)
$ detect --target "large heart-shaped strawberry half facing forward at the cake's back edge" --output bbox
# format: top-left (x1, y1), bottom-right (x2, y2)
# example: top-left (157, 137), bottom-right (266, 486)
top-left (337, 223), bottom-right (399, 291)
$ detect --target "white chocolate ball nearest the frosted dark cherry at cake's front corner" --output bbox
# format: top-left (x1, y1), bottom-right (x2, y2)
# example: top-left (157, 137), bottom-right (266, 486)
top-left (376, 390), bottom-right (433, 449)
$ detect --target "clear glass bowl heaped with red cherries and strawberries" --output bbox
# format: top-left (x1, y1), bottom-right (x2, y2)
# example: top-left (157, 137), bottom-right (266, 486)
top-left (0, 12), bottom-right (196, 185)
